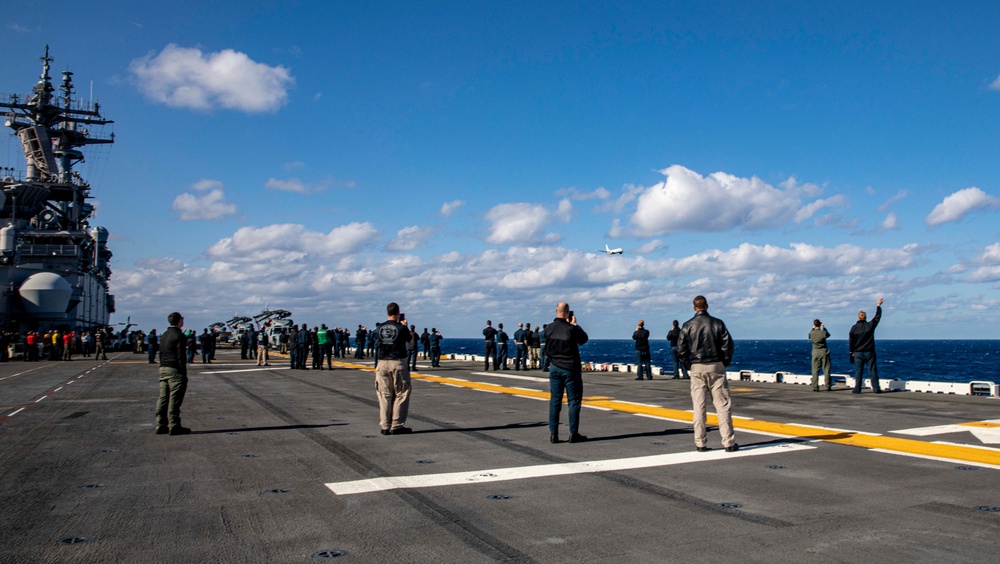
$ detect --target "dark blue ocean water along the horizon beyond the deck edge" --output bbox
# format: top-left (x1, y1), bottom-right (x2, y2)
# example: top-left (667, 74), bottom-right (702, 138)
top-left (441, 338), bottom-right (1000, 383)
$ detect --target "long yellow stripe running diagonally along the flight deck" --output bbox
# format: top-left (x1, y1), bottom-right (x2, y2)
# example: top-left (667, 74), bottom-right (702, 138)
top-left (338, 363), bottom-right (1000, 469)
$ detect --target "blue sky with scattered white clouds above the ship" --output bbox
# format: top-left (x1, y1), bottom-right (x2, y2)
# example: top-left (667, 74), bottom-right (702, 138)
top-left (0, 1), bottom-right (1000, 339)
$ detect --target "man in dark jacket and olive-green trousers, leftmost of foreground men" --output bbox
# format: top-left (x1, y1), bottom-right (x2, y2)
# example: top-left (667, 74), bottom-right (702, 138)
top-left (156, 311), bottom-right (191, 435)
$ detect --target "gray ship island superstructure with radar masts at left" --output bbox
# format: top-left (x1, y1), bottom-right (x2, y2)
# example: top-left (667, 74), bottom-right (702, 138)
top-left (0, 46), bottom-right (115, 333)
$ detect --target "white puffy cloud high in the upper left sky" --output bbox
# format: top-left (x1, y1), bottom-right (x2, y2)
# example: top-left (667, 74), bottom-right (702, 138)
top-left (129, 43), bottom-right (295, 112)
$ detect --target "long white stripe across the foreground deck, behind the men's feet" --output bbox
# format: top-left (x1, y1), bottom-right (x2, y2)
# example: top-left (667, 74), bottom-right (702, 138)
top-left (326, 443), bottom-right (816, 495)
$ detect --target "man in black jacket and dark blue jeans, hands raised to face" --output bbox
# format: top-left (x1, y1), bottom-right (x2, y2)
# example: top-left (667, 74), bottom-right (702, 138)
top-left (545, 302), bottom-right (589, 443)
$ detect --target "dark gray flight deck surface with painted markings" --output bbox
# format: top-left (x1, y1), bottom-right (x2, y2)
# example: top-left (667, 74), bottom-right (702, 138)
top-left (0, 350), bottom-right (1000, 563)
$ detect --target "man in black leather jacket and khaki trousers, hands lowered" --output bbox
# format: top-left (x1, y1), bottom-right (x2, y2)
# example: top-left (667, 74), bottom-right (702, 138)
top-left (677, 296), bottom-right (740, 452)
